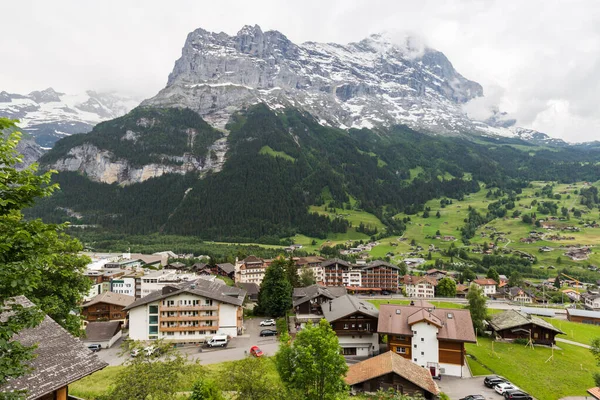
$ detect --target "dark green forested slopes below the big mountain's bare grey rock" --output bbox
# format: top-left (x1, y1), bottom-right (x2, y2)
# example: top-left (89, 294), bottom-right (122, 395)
top-left (30, 105), bottom-right (600, 243)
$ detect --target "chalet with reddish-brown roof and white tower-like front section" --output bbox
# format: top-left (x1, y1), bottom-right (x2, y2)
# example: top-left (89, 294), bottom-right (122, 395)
top-left (377, 301), bottom-right (476, 376)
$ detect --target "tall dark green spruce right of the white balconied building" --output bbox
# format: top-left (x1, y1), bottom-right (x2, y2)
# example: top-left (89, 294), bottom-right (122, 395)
top-left (257, 257), bottom-right (292, 318)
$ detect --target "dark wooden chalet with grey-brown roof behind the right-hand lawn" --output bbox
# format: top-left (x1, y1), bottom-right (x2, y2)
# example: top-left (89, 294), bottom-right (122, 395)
top-left (490, 310), bottom-right (564, 345)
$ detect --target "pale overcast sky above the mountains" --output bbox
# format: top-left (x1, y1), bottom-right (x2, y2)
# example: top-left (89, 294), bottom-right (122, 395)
top-left (0, 0), bottom-right (600, 141)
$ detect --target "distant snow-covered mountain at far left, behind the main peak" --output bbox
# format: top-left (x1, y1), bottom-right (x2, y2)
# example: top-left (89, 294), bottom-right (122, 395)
top-left (0, 88), bottom-right (139, 148)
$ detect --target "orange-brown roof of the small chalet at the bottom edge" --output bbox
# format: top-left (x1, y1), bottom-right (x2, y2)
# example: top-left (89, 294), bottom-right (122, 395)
top-left (345, 351), bottom-right (440, 395)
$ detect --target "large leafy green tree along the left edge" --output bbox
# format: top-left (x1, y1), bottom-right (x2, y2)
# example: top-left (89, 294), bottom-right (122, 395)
top-left (0, 118), bottom-right (91, 398)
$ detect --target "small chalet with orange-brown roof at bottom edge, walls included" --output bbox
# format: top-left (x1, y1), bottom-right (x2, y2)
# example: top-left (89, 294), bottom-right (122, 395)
top-left (345, 351), bottom-right (440, 399)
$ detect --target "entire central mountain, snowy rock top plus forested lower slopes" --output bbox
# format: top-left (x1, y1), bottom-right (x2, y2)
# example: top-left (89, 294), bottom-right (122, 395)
top-left (24, 26), bottom-right (600, 243)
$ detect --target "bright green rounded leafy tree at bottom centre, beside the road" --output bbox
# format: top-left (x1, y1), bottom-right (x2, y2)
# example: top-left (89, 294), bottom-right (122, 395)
top-left (275, 319), bottom-right (348, 400)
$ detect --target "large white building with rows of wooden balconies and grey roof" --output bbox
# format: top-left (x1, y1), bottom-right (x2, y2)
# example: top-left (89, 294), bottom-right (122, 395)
top-left (125, 279), bottom-right (246, 343)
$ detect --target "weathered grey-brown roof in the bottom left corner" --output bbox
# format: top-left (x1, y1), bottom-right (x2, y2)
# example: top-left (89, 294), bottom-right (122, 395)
top-left (0, 296), bottom-right (108, 399)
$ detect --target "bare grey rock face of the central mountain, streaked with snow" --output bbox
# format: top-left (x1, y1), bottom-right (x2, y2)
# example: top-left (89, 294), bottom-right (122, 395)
top-left (142, 26), bottom-right (487, 133)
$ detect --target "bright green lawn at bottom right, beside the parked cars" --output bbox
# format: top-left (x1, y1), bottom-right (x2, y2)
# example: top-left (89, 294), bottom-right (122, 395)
top-left (466, 338), bottom-right (598, 400)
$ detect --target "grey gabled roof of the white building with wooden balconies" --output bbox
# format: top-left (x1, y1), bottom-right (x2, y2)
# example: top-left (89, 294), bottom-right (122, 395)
top-left (123, 279), bottom-right (246, 311)
